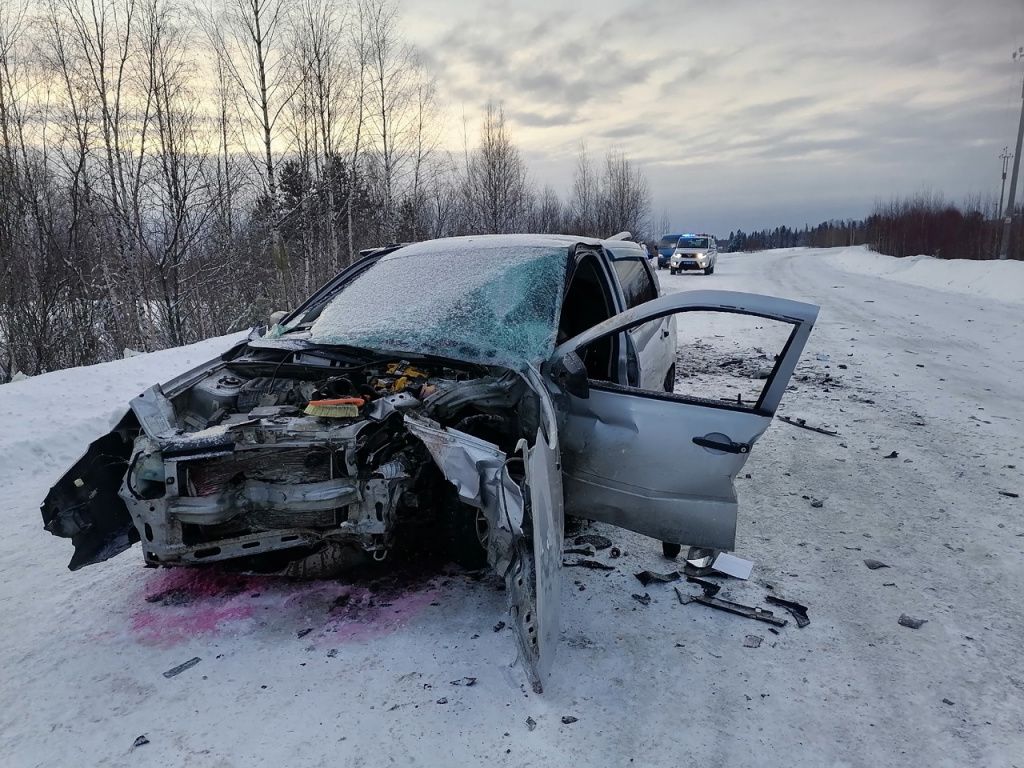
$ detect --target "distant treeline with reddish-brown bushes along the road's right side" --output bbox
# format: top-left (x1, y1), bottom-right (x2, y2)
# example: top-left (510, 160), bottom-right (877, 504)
top-left (724, 195), bottom-right (1024, 259)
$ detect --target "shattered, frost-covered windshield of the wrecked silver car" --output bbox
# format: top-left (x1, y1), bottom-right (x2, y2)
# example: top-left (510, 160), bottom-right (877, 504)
top-left (309, 241), bottom-right (568, 369)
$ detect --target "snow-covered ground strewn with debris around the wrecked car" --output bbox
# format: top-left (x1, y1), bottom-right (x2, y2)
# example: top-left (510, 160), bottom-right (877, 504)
top-left (0, 249), bottom-right (1024, 767)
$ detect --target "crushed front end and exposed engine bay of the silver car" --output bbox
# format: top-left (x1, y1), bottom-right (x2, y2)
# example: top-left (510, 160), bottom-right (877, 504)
top-left (119, 350), bottom-right (538, 578)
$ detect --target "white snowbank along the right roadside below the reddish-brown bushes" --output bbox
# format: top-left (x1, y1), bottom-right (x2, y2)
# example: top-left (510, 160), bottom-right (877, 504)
top-left (825, 246), bottom-right (1024, 304)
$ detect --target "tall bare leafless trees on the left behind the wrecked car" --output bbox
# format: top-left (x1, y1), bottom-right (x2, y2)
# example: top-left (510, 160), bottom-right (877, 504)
top-left (0, 0), bottom-right (650, 383)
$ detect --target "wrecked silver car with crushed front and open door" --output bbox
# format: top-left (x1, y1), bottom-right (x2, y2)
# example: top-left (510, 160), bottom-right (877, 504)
top-left (42, 236), bottom-right (817, 688)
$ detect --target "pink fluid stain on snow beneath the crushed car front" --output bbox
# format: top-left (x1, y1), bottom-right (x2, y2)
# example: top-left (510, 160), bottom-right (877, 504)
top-left (130, 568), bottom-right (438, 646)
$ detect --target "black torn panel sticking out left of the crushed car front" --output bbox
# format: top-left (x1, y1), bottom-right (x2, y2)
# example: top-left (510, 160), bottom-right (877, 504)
top-left (40, 412), bottom-right (139, 570)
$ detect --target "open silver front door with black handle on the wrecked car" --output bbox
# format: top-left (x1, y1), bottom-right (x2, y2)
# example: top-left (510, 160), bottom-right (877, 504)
top-left (546, 291), bottom-right (818, 550)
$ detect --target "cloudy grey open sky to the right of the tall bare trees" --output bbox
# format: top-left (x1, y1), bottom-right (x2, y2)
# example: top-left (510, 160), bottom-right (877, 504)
top-left (402, 0), bottom-right (1024, 237)
